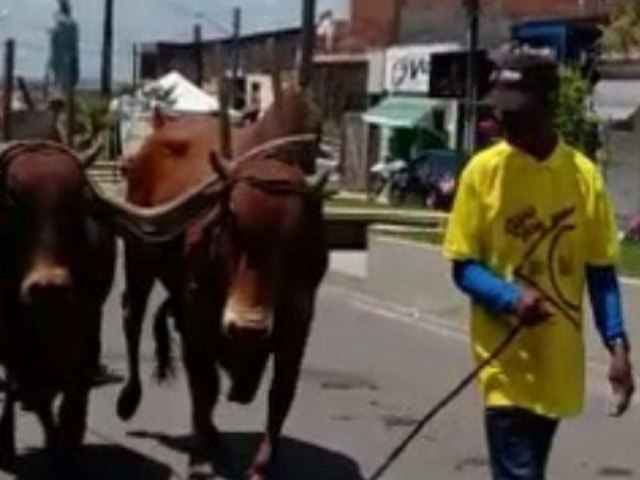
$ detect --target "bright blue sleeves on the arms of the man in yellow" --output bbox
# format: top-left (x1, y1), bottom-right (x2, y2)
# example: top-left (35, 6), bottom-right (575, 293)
top-left (453, 260), bottom-right (625, 344)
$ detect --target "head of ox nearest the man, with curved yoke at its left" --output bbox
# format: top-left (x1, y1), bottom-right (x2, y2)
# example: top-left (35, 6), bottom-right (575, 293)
top-left (87, 152), bottom-right (326, 403)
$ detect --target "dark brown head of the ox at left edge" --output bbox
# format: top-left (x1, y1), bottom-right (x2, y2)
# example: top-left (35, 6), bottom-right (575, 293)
top-left (0, 142), bottom-right (100, 305)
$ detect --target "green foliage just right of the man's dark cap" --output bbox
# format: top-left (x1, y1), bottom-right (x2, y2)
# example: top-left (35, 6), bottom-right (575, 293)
top-left (555, 67), bottom-right (599, 158)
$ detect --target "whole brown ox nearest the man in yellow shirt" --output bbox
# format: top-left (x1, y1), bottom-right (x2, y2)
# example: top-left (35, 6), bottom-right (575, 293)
top-left (90, 91), bottom-right (327, 479)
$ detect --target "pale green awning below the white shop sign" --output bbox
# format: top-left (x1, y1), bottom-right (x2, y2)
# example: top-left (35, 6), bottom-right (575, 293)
top-left (362, 96), bottom-right (443, 128)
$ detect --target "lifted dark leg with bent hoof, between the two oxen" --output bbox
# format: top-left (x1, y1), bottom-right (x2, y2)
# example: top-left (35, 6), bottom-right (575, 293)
top-left (117, 258), bottom-right (154, 421)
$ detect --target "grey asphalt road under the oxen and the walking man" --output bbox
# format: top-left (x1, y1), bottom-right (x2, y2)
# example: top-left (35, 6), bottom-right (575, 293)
top-left (0, 262), bottom-right (640, 480)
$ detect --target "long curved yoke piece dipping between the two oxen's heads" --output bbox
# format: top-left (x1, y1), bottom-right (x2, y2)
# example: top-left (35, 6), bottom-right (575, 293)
top-left (87, 175), bottom-right (226, 243)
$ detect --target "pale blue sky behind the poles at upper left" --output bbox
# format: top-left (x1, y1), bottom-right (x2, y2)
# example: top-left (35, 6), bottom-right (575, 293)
top-left (0, 0), bottom-right (349, 80)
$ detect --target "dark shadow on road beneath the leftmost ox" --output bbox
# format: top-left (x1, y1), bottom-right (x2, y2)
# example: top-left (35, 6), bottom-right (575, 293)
top-left (10, 445), bottom-right (172, 480)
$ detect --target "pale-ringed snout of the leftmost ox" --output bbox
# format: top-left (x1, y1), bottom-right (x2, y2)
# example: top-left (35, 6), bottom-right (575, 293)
top-left (20, 261), bottom-right (72, 304)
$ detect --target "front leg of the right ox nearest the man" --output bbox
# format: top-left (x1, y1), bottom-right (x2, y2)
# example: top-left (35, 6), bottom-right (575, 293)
top-left (247, 298), bottom-right (313, 480)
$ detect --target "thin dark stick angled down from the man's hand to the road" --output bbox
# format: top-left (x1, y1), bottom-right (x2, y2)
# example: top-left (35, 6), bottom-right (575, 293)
top-left (368, 323), bottom-right (523, 480)
